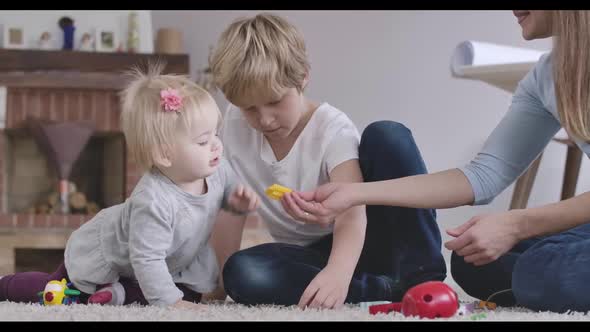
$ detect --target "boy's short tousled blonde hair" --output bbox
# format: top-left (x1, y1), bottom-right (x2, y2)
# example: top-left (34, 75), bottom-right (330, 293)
top-left (209, 13), bottom-right (310, 105)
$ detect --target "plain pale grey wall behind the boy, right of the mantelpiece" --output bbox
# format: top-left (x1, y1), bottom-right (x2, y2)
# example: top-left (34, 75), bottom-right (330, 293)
top-left (153, 10), bottom-right (590, 296)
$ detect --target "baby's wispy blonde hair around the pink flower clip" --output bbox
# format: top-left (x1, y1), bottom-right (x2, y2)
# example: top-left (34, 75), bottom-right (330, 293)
top-left (121, 63), bottom-right (219, 170)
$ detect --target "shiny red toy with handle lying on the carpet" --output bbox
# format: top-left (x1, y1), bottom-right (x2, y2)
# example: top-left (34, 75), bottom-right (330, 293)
top-left (369, 281), bottom-right (459, 318)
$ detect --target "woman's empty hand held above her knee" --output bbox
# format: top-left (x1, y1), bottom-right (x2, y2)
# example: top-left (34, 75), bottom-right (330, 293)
top-left (445, 210), bottom-right (524, 266)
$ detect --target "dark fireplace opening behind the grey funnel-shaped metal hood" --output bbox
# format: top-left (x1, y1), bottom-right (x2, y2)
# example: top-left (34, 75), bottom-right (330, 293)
top-left (4, 129), bottom-right (125, 214)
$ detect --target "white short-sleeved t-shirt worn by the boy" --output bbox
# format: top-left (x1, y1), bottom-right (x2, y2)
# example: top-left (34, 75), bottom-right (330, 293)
top-left (220, 103), bottom-right (360, 245)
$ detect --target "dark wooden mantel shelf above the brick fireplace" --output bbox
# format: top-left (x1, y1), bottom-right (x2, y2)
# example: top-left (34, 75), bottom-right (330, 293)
top-left (0, 49), bottom-right (190, 74)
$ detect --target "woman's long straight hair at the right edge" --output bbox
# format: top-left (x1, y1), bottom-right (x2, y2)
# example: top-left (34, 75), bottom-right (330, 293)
top-left (552, 10), bottom-right (590, 142)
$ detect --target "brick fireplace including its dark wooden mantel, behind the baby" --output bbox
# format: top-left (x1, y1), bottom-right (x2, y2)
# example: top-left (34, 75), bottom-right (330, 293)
top-left (0, 49), bottom-right (189, 275)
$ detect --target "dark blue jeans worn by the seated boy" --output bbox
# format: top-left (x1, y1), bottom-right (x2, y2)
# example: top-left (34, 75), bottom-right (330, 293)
top-left (223, 121), bottom-right (446, 305)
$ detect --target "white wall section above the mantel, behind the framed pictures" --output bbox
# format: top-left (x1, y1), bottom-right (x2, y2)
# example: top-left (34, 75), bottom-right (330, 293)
top-left (0, 10), bottom-right (154, 53)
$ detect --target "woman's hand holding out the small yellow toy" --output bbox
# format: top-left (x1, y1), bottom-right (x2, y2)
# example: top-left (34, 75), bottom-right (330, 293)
top-left (281, 182), bottom-right (355, 227)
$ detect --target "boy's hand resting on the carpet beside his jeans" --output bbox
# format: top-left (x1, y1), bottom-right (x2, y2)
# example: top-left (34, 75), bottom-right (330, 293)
top-left (299, 264), bottom-right (352, 309)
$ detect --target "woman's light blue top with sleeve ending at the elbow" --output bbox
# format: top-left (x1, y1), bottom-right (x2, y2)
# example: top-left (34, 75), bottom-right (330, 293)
top-left (459, 53), bottom-right (590, 205)
